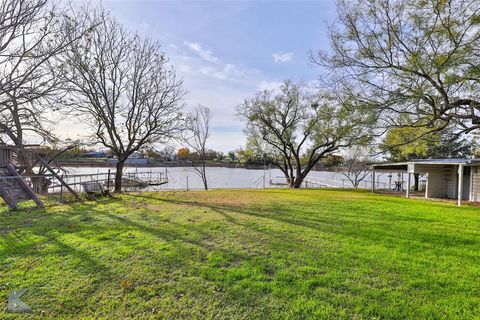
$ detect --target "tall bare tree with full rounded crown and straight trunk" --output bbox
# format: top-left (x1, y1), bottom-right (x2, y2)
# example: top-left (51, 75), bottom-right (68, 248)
top-left (62, 8), bottom-right (184, 192)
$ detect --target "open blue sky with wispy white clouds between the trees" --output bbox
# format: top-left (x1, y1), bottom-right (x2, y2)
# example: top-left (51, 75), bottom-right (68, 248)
top-left (59, 0), bottom-right (335, 152)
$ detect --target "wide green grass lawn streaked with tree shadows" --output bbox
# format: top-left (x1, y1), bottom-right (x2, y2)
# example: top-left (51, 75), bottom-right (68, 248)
top-left (0, 190), bottom-right (480, 319)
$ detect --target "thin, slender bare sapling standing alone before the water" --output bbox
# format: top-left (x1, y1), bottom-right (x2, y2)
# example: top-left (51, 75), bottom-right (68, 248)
top-left (183, 105), bottom-right (212, 190)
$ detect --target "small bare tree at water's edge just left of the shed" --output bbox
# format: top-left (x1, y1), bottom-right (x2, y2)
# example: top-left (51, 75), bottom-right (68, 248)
top-left (339, 146), bottom-right (371, 188)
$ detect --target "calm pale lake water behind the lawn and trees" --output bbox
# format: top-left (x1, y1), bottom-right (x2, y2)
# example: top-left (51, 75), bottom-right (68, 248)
top-left (62, 167), bottom-right (394, 190)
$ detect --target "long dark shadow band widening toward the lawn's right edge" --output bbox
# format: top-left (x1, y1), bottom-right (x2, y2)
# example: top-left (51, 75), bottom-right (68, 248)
top-left (129, 194), bottom-right (480, 255)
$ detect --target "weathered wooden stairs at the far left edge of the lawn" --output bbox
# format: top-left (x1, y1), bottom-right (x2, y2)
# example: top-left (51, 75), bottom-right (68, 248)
top-left (0, 163), bottom-right (43, 209)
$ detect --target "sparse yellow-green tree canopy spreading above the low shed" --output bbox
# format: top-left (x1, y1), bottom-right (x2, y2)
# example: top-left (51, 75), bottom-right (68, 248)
top-left (312, 0), bottom-right (480, 137)
